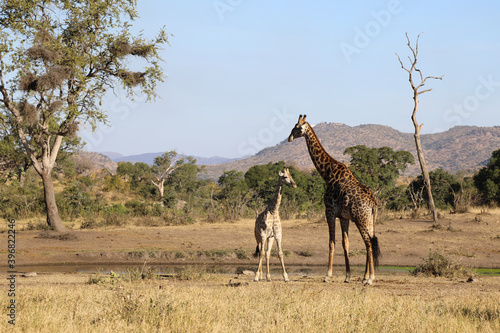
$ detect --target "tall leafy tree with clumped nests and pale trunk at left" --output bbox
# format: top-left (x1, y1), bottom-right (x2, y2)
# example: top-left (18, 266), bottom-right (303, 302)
top-left (0, 0), bottom-right (168, 231)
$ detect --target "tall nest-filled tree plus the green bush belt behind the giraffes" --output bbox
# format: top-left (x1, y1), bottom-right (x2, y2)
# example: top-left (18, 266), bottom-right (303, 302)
top-left (0, 0), bottom-right (500, 231)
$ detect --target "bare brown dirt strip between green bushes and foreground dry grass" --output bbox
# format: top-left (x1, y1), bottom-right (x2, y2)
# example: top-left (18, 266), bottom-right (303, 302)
top-left (0, 213), bottom-right (500, 271)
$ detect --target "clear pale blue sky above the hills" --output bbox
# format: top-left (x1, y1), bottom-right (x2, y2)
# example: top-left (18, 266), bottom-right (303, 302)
top-left (82, 0), bottom-right (500, 158)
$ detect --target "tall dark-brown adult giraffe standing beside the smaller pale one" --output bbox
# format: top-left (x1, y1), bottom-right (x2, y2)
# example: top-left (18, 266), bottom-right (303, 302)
top-left (288, 115), bottom-right (380, 285)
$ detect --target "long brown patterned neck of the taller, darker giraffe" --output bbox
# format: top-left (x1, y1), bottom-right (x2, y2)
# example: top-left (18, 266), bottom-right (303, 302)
top-left (304, 124), bottom-right (351, 183)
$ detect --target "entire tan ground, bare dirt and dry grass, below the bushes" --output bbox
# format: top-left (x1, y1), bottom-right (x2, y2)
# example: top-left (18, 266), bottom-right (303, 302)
top-left (0, 211), bottom-right (500, 333)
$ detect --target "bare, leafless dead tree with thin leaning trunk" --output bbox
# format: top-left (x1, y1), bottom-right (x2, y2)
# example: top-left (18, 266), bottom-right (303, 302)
top-left (396, 34), bottom-right (443, 222)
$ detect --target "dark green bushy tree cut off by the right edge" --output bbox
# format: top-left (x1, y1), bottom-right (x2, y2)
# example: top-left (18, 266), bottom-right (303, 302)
top-left (473, 149), bottom-right (500, 204)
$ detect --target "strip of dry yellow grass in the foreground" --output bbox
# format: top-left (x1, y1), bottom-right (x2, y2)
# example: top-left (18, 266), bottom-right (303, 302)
top-left (0, 274), bottom-right (500, 332)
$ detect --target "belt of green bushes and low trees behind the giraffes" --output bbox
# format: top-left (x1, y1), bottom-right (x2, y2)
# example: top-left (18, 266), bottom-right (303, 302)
top-left (0, 146), bottom-right (500, 228)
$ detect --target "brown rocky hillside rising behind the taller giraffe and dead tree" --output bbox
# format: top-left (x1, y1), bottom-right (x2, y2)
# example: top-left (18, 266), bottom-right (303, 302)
top-left (203, 123), bottom-right (500, 179)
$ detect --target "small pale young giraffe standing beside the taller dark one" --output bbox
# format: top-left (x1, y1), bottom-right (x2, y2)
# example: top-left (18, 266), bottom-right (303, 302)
top-left (254, 168), bottom-right (297, 282)
